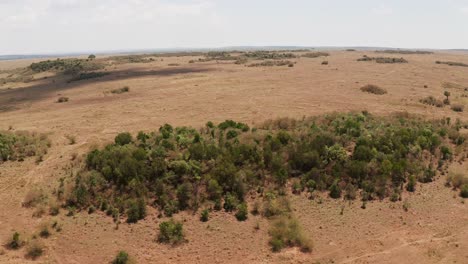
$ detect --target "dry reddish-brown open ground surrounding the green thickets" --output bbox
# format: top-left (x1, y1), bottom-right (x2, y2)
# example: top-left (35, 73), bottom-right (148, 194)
top-left (0, 51), bottom-right (468, 263)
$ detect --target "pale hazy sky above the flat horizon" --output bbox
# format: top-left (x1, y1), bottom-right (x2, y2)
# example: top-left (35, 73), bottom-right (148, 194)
top-left (0, 0), bottom-right (468, 55)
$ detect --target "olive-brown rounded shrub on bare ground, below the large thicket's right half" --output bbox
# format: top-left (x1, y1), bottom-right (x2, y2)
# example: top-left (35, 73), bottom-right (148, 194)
top-left (269, 217), bottom-right (312, 252)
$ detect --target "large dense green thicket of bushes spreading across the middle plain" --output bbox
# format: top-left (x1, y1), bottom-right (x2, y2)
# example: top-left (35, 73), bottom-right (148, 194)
top-left (61, 112), bottom-right (465, 222)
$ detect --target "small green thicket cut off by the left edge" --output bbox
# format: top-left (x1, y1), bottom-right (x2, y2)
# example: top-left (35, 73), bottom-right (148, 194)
top-left (0, 131), bottom-right (51, 164)
